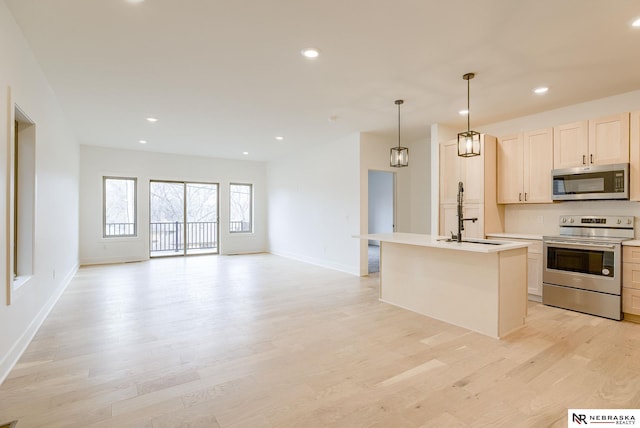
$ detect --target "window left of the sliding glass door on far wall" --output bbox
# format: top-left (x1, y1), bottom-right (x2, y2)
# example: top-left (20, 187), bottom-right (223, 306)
top-left (102, 177), bottom-right (137, 238)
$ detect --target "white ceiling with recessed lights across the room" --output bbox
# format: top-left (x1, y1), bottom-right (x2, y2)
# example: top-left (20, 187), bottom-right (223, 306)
top-left (4, 0), bottom-right (640, 160)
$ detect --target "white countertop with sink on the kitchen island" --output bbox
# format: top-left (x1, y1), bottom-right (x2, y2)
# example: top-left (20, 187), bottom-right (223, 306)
top-left (355, 232), bottom-right (527, 253)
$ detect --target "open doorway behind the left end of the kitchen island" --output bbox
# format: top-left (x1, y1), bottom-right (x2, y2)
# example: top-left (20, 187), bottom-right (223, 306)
top-left (367, 171), bottom-right (395, 274)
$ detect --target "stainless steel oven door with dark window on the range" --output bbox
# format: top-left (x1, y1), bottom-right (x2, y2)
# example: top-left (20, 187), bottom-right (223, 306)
top-left (542, 239), bottom-right (622, 295)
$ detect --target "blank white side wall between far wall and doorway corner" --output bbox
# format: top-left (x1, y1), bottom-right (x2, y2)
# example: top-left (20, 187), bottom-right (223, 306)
top-left (267, 134), bottom-right (366, 274)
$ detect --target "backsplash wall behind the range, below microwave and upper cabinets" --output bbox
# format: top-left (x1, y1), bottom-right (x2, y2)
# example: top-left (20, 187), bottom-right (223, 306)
top-left (505, 201), bottom-right (640, 239)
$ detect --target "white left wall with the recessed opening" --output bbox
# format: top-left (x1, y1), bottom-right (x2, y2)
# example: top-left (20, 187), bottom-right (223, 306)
top-left (0, 2), bottom-right (79, 381)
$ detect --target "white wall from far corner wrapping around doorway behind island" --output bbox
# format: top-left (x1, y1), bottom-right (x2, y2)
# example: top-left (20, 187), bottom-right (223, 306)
top-left (267, 133), bottom-right (430, 275)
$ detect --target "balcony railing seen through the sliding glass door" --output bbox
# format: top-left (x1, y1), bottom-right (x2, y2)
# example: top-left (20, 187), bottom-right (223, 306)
top-left (149, 221), bottom-right (218, 253)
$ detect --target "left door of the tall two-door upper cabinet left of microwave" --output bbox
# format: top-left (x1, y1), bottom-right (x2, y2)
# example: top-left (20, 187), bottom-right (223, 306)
top-left (498, 134), bottom-right (524, 204)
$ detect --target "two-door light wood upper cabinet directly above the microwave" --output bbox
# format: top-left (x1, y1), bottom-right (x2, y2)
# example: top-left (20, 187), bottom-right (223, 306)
top-left (553, 113), bottom-right (629, 169)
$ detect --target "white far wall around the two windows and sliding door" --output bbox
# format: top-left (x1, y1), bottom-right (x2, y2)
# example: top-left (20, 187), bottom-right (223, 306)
top-left (80, 145), bottom-right (267, 264)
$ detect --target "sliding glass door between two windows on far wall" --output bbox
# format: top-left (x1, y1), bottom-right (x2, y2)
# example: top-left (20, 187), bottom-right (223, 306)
top-left (149, 181), bottom-right (218, 257)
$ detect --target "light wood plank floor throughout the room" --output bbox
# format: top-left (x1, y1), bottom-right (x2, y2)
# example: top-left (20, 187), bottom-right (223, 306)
top-left (0, 254), bottom-right (640, 428)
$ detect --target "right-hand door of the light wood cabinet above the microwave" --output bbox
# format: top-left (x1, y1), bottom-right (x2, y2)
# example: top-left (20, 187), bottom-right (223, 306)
top-left (588, 113), bottom-right (629, 165)
